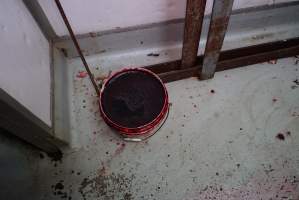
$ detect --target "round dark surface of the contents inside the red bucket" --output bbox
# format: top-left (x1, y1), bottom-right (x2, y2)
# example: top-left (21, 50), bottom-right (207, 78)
top-left (101, 70), bottom-right (165, 128)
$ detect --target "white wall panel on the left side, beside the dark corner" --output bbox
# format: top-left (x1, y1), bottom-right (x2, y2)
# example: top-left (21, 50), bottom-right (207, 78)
top-left (0, 0), bottom-right (51, 125)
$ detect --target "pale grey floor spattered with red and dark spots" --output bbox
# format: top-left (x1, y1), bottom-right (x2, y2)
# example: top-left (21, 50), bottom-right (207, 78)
top-left (28, 58), bottom-right (299, 200)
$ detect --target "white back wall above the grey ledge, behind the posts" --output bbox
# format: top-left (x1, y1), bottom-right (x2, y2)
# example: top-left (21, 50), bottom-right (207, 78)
top-left (38, 0), bottom-right (292, 36)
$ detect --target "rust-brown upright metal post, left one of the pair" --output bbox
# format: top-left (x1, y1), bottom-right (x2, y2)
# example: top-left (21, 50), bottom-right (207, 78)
top-left (181, 0), bottom-right (206, 69)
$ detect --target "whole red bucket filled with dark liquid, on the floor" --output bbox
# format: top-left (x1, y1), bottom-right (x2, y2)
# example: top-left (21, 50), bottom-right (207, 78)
top-left (100, 68), bottom-right (169, 141)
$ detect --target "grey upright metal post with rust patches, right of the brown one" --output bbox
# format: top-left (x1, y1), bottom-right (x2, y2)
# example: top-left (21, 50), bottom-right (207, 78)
top-left (200, 0), bottom-right (234, 80)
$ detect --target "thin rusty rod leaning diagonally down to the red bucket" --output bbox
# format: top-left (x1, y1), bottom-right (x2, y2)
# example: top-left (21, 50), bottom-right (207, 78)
top-left (55, 0), bottom-right (100, 96)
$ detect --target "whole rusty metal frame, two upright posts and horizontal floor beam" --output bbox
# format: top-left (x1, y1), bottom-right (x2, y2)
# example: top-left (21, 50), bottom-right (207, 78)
top-left (145, 0), bottom-right (299, 82)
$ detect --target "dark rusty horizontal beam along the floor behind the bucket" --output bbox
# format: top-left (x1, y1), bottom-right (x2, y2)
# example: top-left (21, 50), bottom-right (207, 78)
top-left (145, 38), bottom-right (299, 83)
